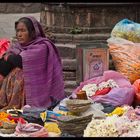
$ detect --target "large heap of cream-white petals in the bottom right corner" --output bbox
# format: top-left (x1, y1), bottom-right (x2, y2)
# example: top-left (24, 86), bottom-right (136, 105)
top-left (83, 107), bottom-right (140, 137)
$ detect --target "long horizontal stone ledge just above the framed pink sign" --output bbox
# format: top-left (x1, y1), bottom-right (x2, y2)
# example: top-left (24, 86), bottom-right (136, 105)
top-left (54, 33), bottom-right (110, 43)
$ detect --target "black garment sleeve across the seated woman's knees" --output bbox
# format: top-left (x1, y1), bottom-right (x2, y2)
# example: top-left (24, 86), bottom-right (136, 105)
top-left (0, 54), bottom-right (22, 76)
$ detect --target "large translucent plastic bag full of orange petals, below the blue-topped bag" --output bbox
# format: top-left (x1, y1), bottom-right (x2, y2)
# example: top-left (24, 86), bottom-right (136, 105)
top-left (107, 37), bottom-right (140, 83)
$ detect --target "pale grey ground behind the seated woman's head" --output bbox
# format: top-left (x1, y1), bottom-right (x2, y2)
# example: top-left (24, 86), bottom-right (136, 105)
top-left (0, 13), bottom-right (40, 38)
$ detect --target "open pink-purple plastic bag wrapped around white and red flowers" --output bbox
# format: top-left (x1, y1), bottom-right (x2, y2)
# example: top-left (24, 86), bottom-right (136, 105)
top-left (72, 70), bottom-right (135, 106)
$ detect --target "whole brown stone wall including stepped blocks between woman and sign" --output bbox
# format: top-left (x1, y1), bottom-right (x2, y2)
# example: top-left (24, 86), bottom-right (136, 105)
top-left (40, 2), bottom-right (140, 94)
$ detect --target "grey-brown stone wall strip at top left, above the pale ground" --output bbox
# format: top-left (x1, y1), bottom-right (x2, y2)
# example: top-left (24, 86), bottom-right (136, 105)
top-left (0, 3), bottom-right (41, 14)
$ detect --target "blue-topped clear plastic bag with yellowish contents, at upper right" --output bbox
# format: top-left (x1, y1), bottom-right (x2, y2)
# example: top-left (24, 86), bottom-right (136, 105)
top-left (111, 19), bottom-right (140, 43)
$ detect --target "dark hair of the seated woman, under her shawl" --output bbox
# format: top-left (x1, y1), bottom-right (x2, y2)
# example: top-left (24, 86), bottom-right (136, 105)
top-left (15, 17), bottom-right (35, 39)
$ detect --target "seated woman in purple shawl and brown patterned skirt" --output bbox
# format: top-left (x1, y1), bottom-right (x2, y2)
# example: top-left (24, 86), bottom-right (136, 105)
top-left (0, 17), bottom-right (65, 109)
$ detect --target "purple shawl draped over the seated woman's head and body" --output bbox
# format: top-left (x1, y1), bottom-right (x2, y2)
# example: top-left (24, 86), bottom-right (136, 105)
top-left (8, 17), bottom-right (65, 107)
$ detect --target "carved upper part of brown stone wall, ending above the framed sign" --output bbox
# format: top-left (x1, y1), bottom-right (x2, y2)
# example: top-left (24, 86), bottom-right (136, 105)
top-left (41, 3), bottom-right (140, 43)
